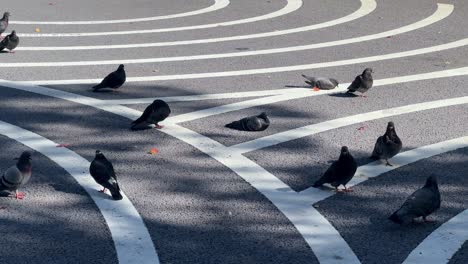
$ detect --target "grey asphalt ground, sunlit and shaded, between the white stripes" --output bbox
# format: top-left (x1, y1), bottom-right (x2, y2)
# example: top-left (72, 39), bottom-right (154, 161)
top-left (0, 0), bottom-right (468, 264)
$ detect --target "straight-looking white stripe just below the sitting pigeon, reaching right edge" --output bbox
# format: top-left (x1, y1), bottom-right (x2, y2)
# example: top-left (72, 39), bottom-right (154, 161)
top-left (230, 96), bottom-right (468, 153)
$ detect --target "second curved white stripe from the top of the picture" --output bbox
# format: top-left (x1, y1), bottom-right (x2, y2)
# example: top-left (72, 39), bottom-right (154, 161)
top-left (18, 0), bottom-right (302, 38)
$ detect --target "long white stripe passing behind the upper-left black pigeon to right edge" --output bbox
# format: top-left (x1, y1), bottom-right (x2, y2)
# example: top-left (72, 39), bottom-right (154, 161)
top-left (21, 38), bottom-right (468, 85)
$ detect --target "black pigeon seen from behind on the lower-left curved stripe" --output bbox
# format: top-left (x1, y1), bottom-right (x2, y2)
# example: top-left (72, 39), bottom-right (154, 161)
top-left (89, 150), bottom-right (123, 200)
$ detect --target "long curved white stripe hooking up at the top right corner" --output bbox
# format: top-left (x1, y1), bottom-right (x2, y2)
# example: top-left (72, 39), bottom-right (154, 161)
top-left (0, 4), bottom-right (453, 68)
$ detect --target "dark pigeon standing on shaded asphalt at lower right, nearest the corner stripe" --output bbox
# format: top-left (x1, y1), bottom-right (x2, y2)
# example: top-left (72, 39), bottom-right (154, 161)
top-left (389, 175), bottom-right (440, 225)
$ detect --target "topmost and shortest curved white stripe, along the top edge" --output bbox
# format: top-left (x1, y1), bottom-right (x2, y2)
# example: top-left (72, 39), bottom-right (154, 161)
top-left (10, 0), bottom-right (230, 25)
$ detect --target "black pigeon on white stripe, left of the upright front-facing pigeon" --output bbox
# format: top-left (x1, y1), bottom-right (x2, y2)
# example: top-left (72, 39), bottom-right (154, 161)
top-left (312, 146), bottom-right (357, 192)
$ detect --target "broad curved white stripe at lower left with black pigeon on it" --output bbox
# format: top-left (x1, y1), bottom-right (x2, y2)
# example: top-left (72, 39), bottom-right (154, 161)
top-left (0, 121), bottom-right (159, 264)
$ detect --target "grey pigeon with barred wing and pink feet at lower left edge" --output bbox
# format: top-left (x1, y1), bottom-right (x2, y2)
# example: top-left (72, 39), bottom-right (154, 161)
top-left (0, 151), bottom-right (32, 199)
